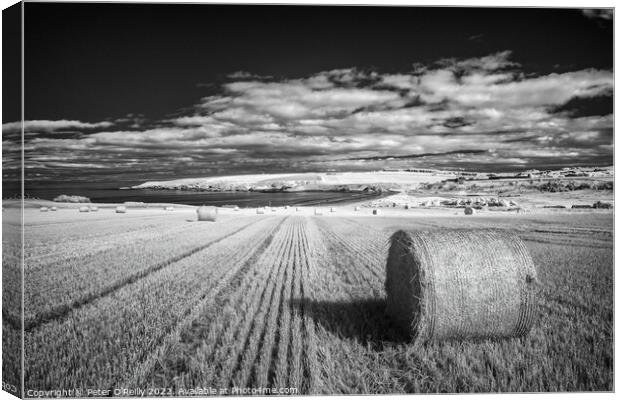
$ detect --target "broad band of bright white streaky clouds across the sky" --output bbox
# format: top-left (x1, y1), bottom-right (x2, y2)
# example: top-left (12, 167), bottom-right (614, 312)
top-left (9, 51), bottom-right (613, 180)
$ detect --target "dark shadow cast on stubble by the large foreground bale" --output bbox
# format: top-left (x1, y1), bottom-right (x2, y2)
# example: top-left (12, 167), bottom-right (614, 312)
top-left (289, 298), bottom-right (410, 351)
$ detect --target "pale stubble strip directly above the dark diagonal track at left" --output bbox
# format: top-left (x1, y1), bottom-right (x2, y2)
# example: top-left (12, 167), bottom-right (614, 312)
top-left (24, 219), bottom-right (256, 324)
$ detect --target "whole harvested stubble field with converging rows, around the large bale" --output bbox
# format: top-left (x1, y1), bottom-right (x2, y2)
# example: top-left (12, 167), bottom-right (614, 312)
top-left (3, 209), bottom-right (613, 395)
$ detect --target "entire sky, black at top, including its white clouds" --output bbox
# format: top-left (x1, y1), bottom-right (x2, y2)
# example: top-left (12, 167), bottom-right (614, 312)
top-left (3, 3), bottom-right (613, 183)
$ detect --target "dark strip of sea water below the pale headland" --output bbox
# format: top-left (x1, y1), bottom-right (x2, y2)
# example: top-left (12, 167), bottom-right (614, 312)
top-left (2, 181), bottom-right (386, 208)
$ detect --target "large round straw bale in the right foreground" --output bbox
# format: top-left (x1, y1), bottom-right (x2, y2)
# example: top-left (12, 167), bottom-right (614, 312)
top-left (385, 229), bottom-right (536, 342)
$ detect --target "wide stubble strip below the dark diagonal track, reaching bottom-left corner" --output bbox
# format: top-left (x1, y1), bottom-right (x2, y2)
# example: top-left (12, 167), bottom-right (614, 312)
top-left (26, 219), bottom-right (284, 388)
